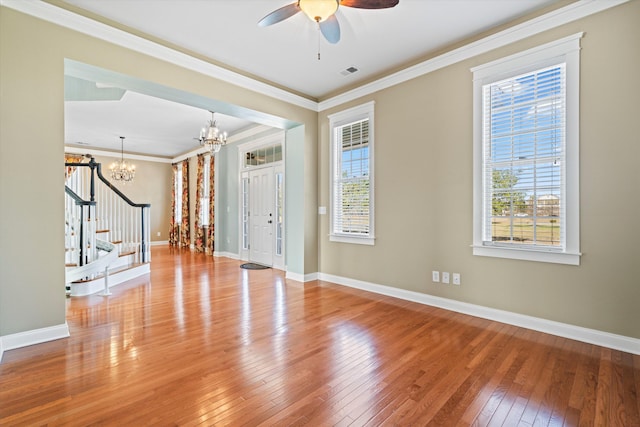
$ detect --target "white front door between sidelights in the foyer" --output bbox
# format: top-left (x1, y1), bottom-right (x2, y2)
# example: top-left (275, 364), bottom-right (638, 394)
top-left (249, 167), bottom-right (275, 266)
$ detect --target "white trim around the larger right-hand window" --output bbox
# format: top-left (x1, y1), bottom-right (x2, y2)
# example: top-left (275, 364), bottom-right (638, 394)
top-left (471, 33), bottom-right (584, 265)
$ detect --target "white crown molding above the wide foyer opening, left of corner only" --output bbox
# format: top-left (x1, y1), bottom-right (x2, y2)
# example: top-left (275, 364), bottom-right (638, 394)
top-left (0, 0), bottom-right (318, 111)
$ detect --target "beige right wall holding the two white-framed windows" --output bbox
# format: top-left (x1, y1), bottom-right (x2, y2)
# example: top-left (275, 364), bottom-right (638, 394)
top-left (319, 1), bottom-right (640, 338)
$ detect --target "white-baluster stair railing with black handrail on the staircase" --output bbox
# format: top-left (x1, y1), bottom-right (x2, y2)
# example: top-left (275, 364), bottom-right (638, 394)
top-left (65, 157), bottom-right (151, 262)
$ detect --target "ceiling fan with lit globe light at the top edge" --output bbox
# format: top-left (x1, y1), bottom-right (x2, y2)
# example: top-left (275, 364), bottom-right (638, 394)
top-left (258, 0), bottom-right (400, 43)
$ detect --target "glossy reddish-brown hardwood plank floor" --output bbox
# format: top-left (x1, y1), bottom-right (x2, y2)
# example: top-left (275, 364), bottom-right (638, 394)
top-left (0, 247), bottom-right (640, 426)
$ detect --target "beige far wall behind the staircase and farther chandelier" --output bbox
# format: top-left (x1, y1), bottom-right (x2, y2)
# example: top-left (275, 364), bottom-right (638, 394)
top-left (91, 155), bottom-right (173, 242)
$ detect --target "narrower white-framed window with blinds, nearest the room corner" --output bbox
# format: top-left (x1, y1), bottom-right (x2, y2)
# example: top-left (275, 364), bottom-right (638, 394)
top-left (329, 103), bottom-right (374, 245)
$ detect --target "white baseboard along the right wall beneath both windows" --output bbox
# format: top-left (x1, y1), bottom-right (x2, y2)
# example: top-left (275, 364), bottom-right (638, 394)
top-left (318, 273), bottom-right (640, 355)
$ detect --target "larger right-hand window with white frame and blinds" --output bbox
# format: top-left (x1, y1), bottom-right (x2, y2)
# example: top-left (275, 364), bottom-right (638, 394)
top-left (473, 35), bottom-right (581, 264)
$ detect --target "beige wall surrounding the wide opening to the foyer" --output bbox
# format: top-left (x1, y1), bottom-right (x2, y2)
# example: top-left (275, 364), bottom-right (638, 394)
top-left (0, 7), bottom-right (317, 336)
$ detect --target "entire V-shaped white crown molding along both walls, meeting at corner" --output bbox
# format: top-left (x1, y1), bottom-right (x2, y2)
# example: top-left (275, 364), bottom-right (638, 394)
top-left (0, 0), bottom-right (630, 112)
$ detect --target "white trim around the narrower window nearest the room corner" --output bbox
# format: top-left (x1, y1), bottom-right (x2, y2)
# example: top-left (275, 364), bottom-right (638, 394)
top-left (328, 101), bottom-right (375, 245)
